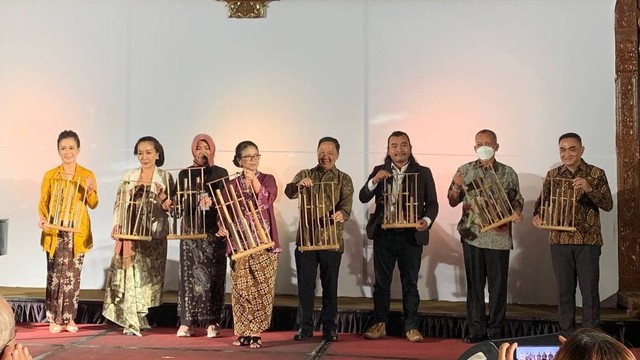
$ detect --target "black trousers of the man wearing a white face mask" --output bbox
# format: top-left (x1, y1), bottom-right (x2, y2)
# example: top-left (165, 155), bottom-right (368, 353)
top-left (462, 241), bottom-right (509, 338)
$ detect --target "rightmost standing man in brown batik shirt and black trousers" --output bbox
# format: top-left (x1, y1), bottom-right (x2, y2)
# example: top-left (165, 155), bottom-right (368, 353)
top-left (532, 133), bottom-right (613, 335)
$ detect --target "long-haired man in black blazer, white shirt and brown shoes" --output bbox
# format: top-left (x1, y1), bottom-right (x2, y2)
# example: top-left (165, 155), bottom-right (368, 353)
top-left (359, 131), bottom-right (438, 342)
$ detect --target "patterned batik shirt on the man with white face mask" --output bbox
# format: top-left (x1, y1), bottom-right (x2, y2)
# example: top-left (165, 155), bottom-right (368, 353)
top-left (449, 160), bottom-right (524, 250)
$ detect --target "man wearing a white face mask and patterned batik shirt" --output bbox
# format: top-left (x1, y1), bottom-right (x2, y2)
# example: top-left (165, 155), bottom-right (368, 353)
top-left (447, 129), bottom-right (524, 343)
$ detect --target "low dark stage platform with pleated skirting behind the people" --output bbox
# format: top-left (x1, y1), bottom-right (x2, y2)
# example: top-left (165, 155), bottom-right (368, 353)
top-left (0, 287), bottom-right (640, 347)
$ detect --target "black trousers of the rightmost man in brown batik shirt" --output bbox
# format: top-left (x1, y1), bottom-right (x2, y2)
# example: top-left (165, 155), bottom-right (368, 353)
top-left (551, 245), bottom-right (602, 333)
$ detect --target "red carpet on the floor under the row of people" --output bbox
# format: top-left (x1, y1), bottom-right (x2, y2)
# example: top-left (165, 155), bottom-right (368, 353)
top-left (17, 324), bottom-right (640, 360)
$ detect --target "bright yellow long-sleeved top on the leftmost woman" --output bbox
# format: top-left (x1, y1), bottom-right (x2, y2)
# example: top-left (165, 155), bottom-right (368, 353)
top-left (38, 165), bottom-right (98, 258)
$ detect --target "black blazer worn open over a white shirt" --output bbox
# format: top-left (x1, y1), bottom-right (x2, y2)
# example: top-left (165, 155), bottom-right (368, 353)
top-left (359, 161), bottom-right (439, 245)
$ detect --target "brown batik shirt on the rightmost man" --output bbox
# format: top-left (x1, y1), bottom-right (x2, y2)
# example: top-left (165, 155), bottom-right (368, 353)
top-left (533, 160), bottom-right (613, 245)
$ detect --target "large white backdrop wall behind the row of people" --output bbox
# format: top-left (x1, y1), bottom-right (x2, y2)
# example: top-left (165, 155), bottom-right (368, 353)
top-left (0, 0), bottom-right (618, 304)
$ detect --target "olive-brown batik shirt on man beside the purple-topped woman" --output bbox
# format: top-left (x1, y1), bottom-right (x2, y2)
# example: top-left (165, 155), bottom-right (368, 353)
top-left (284, 165), bottom-right (353, 252)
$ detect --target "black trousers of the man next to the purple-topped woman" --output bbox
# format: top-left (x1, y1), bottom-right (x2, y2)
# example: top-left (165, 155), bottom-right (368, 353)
top-left (295, 248), bottom-right (342, 331)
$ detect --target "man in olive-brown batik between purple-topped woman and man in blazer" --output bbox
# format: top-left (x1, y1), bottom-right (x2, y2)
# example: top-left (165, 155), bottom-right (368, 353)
top-left (284, 136), bottom-right (353, 341)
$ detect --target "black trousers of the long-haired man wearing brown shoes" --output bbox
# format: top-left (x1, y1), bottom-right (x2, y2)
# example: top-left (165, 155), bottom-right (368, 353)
top-left (373, 230), bottom-right (422, 332)
